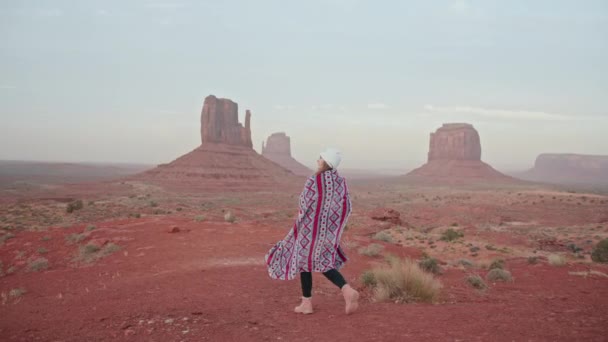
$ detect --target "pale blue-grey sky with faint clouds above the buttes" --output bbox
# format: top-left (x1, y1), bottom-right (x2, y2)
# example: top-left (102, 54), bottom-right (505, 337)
top-left (0, 0), bottom-right (608, 170)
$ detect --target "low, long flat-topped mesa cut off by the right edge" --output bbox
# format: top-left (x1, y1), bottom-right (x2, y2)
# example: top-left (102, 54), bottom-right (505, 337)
top-left (518, 153), bottom-right (608, 184)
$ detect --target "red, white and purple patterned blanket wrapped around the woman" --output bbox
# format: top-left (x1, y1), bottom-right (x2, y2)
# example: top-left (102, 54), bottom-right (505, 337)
top-left (265, 170), bottom-right (351, 280)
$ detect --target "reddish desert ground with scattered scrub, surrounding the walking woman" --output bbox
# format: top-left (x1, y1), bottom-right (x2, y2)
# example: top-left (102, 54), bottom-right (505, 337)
top-left (0, 177), bottom-right (608, 341)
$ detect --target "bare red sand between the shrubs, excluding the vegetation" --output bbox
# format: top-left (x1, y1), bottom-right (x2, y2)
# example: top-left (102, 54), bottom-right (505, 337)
top-left (0, 180), bottom-right (608, 341)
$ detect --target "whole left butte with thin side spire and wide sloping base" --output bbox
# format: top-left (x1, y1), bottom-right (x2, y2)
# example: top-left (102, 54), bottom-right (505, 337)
top-left (133, 95), bottom-right (301, 190)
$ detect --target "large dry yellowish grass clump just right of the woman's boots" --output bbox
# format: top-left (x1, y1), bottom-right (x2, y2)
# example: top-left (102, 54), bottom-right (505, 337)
top-left (362, 258), bottom-right (441, 303)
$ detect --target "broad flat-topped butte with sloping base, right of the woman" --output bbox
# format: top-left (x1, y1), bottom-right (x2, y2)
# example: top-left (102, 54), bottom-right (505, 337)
top-left (407, 123), bottom-right (513, 183)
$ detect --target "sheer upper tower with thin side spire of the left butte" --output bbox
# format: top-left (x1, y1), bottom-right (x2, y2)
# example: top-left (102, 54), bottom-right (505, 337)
top-left (201, 95), bottom-right (253, 147)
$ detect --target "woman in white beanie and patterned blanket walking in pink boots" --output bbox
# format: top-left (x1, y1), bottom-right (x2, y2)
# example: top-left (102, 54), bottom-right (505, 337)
top-left (266, 148), bottom-right (359, 314)
